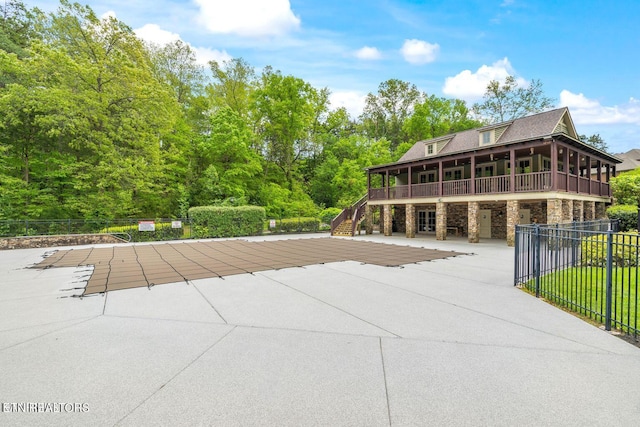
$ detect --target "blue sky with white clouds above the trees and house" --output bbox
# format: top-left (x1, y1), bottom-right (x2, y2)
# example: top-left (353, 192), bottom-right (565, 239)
top-left (24, 0), bottom-right (640, 153)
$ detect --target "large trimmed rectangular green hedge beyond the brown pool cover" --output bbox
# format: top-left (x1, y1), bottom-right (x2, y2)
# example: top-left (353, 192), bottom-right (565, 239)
top-left (189, 206), bottom-right (265, 238)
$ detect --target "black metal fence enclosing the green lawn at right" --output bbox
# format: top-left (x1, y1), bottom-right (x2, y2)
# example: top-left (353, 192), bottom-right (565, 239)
top-left (514, 220), bottom-right (640, 339)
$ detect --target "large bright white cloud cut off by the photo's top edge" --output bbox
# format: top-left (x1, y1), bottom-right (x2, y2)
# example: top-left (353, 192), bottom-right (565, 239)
top-left (195, 0), bottom-right (300, 37)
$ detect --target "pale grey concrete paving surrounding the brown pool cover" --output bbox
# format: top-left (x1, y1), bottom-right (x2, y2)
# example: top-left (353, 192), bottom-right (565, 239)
top-left (0, 235), bottom-right (640, 426)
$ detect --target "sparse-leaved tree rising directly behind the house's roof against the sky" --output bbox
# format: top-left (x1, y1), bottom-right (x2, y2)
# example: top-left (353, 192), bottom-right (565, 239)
top-left (473, 76), bottom-right (555, 123)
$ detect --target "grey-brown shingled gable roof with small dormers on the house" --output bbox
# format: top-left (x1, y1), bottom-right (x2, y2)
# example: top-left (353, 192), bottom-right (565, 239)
top-left (398, 107), bottom-right (577, 162)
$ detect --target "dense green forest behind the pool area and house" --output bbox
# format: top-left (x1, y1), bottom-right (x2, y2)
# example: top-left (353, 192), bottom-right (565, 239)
top-left (0, 0), bottom-right (568, 219)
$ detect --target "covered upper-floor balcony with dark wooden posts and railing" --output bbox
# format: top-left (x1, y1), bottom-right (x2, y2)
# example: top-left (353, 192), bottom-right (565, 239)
top-left (368, 140), bottom-right (615, 202)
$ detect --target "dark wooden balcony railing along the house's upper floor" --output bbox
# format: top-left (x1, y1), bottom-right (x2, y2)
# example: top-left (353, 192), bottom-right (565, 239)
top-left (369, 172), bottom-right (611, 200)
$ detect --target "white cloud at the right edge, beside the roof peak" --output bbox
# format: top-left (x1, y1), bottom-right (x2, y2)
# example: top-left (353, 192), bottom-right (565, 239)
top-left (559, 89), bottom-right (640, 125)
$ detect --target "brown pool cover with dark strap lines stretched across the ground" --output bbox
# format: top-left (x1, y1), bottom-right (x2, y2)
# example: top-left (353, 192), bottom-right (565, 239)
top-left (33, 238), bottom-right (462, 295)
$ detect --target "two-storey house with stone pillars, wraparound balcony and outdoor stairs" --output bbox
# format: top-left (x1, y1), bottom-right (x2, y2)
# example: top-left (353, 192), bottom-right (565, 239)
top-left (332, 108), bottom-right (620, 245)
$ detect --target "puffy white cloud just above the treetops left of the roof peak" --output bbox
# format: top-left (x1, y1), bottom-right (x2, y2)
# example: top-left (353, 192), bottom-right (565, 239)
top-left (442, 57), bottom-right (527, 103)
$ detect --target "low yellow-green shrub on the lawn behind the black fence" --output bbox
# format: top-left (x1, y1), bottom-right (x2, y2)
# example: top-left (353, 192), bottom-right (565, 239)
top-left (581, 231), bottom-right (639, 267)
